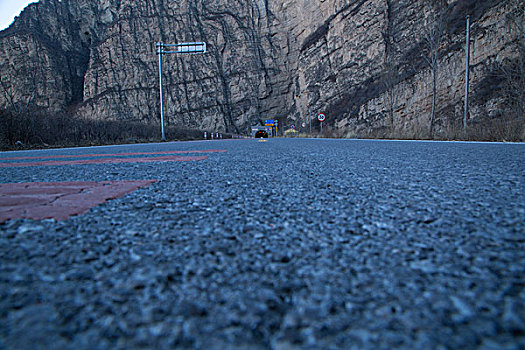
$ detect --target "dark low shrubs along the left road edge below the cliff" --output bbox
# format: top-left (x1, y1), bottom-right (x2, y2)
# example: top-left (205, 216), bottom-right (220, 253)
top-left (0, 110), bottom-right (223, 150)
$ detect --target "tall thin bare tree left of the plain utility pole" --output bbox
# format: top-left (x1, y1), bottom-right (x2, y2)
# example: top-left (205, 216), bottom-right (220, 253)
top-left (423, 4), bottom-right (446, 137)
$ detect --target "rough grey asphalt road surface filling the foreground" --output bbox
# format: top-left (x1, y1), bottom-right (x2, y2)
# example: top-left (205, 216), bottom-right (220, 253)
top-left (0, 139), bottom-right (525, 350)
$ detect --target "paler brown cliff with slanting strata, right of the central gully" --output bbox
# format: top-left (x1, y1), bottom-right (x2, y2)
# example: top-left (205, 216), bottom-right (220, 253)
top-left (293, 0), bottom-right (518, 137)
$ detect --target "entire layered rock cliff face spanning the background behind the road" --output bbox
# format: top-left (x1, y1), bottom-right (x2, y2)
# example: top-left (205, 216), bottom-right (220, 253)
top-left (0, 0), bottom-right (523, 135)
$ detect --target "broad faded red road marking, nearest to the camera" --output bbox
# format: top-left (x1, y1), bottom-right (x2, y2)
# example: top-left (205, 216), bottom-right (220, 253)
top-left (0, 180), bottom-right (156, 223)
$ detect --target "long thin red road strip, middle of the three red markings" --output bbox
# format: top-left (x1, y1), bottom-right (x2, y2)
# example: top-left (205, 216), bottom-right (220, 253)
top-left (0, 156), bottom-right (208, 168)
